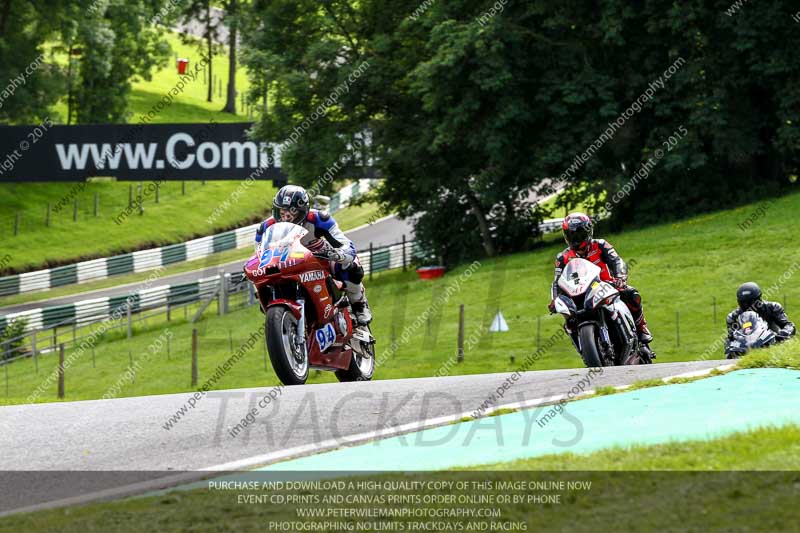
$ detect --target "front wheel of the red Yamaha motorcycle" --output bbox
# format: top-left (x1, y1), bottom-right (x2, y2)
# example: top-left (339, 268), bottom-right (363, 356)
top-left (264, 306), bottom-right (309, 385)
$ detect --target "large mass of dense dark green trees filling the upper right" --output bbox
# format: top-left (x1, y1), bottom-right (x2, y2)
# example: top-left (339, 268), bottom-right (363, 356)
top-left (239, 0), bottom-right (800, 260)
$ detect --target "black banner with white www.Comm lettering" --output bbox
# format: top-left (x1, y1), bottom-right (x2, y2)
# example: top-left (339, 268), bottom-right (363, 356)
top-left (0, 121), bottom-right (286, 184)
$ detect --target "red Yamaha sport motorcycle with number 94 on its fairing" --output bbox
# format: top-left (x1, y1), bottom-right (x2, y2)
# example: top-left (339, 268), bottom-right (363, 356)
top-left (244, 222), bottom-right (375, 385)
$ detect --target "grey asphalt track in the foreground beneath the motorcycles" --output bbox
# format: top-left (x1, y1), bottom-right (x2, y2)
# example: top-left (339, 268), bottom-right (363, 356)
top-left (0, 361), bottom-right (726, 515)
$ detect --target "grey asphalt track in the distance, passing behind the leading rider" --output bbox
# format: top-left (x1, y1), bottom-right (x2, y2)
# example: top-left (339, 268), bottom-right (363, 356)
top-left (0, 215), bottom-right (414, 316)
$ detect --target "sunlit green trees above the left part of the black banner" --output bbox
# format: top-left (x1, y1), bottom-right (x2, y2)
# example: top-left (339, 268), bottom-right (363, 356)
top-left (0, 0), bottom-right (169, 124)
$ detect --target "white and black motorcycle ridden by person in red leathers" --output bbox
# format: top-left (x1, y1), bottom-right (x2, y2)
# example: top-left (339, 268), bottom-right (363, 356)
top-left (555, 258), bottom-right (653, 367)
